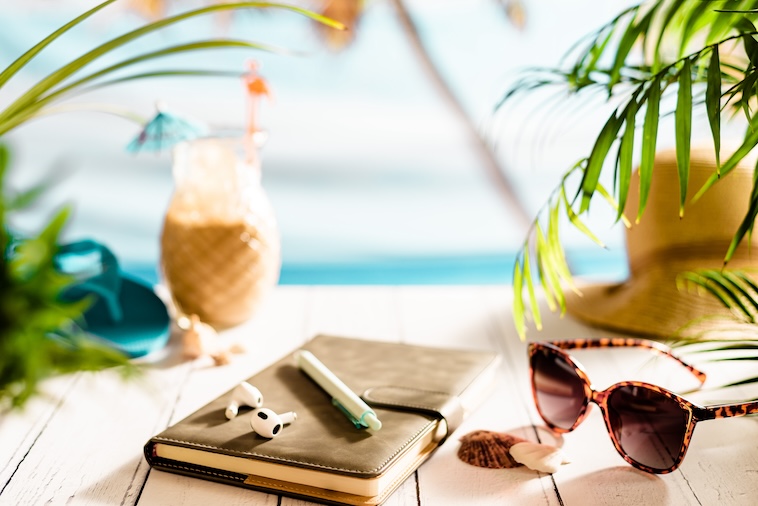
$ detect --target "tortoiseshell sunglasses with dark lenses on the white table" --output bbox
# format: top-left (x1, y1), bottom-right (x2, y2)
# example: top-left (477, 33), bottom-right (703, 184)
top-left (529, 338), bottom-right (758, 474)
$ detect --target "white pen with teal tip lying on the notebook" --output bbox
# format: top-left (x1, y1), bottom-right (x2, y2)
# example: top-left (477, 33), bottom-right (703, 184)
top-left (295, 350), bottom-right (382, 430)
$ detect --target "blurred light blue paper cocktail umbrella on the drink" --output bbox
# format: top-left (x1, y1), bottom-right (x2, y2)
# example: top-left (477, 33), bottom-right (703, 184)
top-left (126, 105), bottom-right (208, 153)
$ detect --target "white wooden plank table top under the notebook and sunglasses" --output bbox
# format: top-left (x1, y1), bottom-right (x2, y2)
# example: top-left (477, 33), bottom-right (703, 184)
top-left (0, 286), bottom-right (758, 506)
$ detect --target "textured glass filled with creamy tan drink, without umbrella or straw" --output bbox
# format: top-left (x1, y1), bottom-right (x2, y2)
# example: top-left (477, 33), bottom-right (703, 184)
top-left (161, 132), bottom-right (281, 327)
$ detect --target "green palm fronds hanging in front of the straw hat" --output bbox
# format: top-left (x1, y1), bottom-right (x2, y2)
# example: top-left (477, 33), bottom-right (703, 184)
top-left (497, 0), bottom-right (758, 340)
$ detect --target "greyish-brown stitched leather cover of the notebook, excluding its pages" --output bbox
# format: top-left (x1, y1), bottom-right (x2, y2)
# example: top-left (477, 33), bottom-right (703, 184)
top-left (145, 335), bottom-right (498, 504)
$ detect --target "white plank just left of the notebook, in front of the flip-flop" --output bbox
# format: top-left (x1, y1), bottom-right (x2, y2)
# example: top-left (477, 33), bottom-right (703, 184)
top-left (2, 360), bottom-right (190, 504)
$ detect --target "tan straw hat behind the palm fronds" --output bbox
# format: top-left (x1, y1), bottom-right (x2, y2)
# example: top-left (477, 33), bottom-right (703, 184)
top-left (566, 144), bottom-right (758, 337)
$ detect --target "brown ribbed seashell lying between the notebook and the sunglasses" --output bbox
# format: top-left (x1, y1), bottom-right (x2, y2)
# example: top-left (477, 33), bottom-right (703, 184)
top-left (458, 430), bottom-right (526, 469)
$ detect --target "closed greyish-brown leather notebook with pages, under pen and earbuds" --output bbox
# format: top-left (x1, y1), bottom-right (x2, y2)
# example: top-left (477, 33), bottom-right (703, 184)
top-left (145, 335), bottom-right (499, 505)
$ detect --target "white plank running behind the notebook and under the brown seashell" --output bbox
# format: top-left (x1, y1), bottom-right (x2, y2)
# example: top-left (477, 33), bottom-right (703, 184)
top-left (400, 287), bottom-right (558, 506)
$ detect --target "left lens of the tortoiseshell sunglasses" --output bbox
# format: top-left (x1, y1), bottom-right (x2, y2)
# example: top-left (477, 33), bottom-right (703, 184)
top-left (531, 349), bottom-right (587, 430)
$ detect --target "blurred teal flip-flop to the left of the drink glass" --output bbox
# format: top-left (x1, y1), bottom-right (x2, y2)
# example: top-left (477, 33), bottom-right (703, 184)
top-left (55, 240), bottom-right (170, 358)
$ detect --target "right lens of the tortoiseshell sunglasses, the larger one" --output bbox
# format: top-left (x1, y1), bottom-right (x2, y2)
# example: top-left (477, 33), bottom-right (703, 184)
top-left (608, 386), bottom-right (689, 471)
